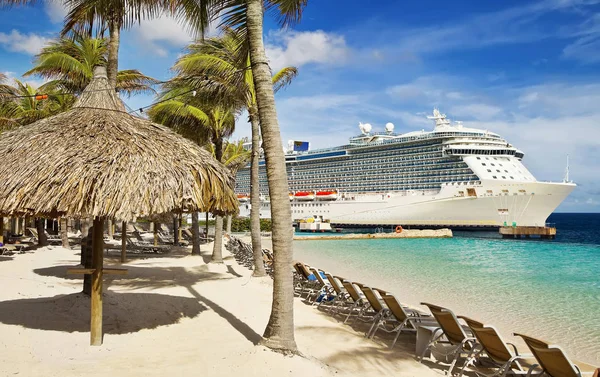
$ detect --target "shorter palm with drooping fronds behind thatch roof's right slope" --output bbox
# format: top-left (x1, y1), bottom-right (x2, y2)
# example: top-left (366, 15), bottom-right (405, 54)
top-left (148, 87), bottom-right (235, 263)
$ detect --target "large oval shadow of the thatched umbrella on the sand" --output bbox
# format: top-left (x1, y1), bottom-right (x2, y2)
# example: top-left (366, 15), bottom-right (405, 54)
top-left (0, 291), bottom-right (206, 334)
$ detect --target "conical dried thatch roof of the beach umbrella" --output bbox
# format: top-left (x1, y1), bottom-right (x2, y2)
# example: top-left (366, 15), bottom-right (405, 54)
top-left (0, 67), bottom-right (238, 221)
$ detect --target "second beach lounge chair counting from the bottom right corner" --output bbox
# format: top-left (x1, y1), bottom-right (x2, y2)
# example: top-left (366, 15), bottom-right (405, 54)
top-left (458, 316), bottom-right (539, 377)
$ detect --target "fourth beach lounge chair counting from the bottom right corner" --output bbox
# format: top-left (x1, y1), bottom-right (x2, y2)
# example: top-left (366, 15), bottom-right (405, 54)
top-left (371, 294), bottom-right (437, 348)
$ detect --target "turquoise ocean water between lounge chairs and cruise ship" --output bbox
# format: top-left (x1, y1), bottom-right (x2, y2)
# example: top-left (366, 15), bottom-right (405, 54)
top-left (294, 213), bottom-right (600, 365)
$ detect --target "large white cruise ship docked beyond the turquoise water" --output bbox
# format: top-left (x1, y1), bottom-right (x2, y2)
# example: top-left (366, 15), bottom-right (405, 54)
top-left (236, 109), bottom-right (576, 228)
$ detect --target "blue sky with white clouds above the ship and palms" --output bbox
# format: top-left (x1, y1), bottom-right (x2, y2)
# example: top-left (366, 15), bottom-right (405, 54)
top-left (0, 0), bottom-right (600, 212)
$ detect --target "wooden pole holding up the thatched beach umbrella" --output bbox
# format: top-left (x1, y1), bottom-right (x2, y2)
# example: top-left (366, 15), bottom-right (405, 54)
top-left (90, 217), bottom-right (104, 346)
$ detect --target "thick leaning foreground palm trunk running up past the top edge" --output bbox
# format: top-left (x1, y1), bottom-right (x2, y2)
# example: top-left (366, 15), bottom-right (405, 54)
top-left (246, 0), bottom-right (297, 353)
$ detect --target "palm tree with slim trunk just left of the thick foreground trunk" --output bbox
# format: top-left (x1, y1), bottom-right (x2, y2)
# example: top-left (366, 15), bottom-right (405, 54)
top-left (174, 28), bottom-right (298, 277)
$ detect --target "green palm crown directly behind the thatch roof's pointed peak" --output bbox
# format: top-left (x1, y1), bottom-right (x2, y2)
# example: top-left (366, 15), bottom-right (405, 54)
top-left (23, 33), bottom-right (158, 95)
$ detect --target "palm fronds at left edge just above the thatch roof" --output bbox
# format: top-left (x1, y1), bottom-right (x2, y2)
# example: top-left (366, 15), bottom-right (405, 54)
top-left (0, 79), bottom-right (75, 130)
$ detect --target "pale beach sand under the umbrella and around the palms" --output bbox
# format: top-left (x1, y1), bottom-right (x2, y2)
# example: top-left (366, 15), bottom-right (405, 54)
top-left (0, 241), bottom-right (443, 377)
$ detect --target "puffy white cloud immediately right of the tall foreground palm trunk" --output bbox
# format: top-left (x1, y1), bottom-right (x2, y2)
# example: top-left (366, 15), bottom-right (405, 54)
top-left (265, 30), bottom-right (350, 71)
